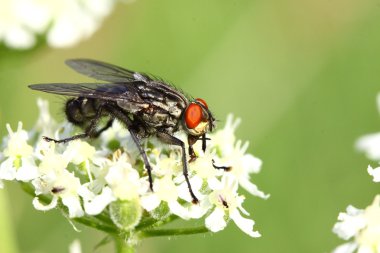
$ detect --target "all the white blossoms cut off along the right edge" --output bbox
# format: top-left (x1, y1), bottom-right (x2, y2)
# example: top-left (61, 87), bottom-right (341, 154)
top-left (333, 94), bottom-right (380, 253)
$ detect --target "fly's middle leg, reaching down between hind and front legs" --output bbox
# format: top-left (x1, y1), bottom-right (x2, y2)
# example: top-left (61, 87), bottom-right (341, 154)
top-left (105, 105), bottom-right (153, 191)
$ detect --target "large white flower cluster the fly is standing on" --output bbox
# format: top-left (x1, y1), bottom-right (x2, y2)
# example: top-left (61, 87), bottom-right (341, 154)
top-left (0, 100), bottom-right (269, 237)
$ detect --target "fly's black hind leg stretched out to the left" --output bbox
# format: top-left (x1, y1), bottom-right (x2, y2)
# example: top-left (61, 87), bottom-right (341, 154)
top-left (42, 107), bottom-right (108, 143)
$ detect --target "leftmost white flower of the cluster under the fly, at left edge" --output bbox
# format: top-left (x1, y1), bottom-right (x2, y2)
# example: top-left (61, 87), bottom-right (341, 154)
top-left (0, 122), bottom-right (38, 181)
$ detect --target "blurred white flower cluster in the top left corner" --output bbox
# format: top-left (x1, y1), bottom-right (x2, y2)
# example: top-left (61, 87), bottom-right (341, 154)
top-left (0, 0), bottom-right (116, 49)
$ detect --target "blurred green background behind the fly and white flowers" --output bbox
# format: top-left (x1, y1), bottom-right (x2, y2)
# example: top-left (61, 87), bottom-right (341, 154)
top-left (0, 0), bottom-right (380, 253)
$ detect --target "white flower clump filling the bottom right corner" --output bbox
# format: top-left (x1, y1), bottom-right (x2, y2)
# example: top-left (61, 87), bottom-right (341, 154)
top-left (333, 195), bottom-right (380, 253)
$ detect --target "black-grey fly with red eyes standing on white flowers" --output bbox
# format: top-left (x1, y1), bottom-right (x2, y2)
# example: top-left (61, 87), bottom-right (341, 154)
top-left (29, 59), bottom-right (215, 203)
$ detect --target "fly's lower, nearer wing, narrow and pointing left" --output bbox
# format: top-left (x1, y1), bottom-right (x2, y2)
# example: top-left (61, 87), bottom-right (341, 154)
top-left (28, 82), bottom-right (145, 104)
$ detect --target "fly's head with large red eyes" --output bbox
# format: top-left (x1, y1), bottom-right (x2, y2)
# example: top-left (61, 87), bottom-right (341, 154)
top-left (183, 98), bottom-right (215, 136)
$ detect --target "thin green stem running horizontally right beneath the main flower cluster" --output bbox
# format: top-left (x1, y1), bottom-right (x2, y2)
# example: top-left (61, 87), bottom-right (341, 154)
top-left (139, 226), bottom-right (210, 238)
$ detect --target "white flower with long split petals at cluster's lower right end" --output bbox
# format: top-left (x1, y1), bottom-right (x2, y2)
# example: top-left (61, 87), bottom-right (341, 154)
top-left (205, 176), bottom-right (261, 237)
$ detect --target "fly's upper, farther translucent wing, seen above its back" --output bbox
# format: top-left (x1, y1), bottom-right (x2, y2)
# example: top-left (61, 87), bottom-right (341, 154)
top-left (66, 59), bottom-right (151, 83)
